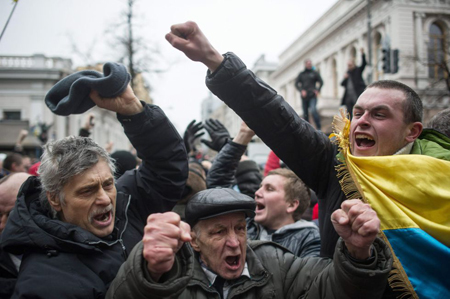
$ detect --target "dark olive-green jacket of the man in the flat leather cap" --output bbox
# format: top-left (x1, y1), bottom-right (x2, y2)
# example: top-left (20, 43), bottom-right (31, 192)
top-left (106, 239), bottom-right (392, 299)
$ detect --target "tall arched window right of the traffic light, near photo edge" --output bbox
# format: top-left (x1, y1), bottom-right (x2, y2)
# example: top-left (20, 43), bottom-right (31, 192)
top-left (428, 23), bottom-right (447, 79)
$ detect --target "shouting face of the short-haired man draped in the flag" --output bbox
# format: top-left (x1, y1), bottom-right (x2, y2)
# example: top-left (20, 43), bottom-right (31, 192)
top-left (350, 87), bottom-right (415, 156)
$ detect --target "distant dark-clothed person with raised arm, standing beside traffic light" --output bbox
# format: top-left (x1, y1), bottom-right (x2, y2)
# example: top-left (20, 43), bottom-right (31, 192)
top-left (341, 48), bottom-right (367, 119)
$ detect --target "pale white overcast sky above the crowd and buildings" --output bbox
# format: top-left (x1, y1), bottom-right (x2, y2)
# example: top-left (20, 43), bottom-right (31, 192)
top-left (0, 0), bottom-right (337, 131)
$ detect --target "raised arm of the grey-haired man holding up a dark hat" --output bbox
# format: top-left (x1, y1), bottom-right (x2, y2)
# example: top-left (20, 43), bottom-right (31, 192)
top-left (90, 86), bottom-right (188, 220)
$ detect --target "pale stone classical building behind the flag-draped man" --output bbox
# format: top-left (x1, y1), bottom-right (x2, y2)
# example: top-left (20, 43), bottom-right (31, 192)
top-left (206, 0), bottom-right (450, 133)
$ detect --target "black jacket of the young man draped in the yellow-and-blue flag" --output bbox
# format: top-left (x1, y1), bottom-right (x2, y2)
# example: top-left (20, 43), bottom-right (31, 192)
top-left (206, 53), bottom-right (346, 258)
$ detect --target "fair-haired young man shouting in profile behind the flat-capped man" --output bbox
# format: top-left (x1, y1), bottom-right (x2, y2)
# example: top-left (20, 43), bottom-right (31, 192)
top-left (207, 122), bottom-right (320, 257)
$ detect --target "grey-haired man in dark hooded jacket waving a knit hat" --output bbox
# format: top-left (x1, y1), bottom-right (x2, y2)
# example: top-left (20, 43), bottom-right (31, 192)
top-left (1, 86), bottom-right (188, 299)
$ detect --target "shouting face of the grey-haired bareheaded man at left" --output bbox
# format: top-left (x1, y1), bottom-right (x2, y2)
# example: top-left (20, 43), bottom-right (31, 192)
top-left (54, 160), bottom-right (117, 237)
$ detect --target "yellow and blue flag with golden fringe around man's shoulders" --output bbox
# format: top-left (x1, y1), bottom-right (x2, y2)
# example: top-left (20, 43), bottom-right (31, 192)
top-left (334, 110), bottom-right (450, 299)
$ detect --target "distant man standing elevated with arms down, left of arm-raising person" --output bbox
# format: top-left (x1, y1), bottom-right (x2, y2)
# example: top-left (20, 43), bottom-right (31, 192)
top-left (295, 59), bottom-right (323, 130)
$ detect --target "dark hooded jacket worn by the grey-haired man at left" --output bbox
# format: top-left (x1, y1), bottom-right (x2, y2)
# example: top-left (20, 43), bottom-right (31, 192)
top-left (1, 105), bottom-right (188, 299)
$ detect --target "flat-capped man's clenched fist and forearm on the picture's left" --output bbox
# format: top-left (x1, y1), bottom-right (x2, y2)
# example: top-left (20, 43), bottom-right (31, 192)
top-left (106, 212), bottom-right (193, 299)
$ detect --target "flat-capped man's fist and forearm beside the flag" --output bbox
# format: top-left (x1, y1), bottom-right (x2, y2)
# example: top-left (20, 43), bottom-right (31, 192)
top-left (282, 199), bottom-right (392, 299)
